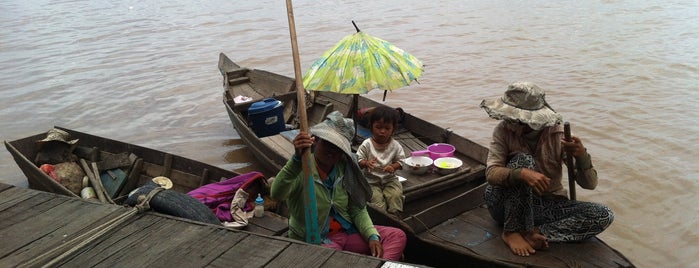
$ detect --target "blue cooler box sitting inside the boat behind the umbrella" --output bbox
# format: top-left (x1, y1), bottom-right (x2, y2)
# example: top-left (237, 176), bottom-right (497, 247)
top-left (248, 98), bottom-right (286, 137)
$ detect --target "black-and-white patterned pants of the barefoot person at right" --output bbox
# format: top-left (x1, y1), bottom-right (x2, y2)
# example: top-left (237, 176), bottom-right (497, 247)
top-left (484, 154), bottom-right (614, 242)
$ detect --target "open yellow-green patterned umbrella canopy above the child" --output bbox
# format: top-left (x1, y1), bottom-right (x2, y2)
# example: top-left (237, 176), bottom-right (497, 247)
top-left (303, 21), bottom-right (423, 94)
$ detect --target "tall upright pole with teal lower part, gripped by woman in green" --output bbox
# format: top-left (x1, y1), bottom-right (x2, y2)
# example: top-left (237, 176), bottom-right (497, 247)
top-left (286, 0), bottom-right (320, 244)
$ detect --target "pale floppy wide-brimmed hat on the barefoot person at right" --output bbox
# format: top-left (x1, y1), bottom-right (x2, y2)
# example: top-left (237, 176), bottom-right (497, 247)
top-left (480, 82), bottom-right (563, 130)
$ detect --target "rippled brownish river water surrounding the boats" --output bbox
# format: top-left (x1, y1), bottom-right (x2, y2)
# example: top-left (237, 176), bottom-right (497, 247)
top-left (0, 0), bottom-right (699, 267)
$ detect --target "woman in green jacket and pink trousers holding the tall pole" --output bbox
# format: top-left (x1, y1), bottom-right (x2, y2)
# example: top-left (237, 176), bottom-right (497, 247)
top-left (271, 111), bottom-right (407, 260)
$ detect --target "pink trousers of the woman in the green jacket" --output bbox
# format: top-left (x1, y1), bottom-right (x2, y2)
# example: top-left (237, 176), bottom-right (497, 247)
top-left (322, 225), bottom-right (407, 261)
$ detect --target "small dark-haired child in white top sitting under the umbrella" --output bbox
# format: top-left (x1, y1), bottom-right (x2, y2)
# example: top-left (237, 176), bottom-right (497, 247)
top-left (357, 106), bottom-right (405, 213)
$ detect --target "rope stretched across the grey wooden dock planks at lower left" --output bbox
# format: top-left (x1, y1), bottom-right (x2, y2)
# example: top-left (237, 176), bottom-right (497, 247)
top-left (17, 187), bottom-right (165, 267)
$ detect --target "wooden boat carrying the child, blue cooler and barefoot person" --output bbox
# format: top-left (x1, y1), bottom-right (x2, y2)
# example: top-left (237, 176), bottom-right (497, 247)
top-left (218, 53), bottom-right (633, 267)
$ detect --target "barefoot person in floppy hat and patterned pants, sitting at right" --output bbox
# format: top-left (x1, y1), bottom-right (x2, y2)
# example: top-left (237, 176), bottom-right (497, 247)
top-left (480, 82), bottom-right (614, 256)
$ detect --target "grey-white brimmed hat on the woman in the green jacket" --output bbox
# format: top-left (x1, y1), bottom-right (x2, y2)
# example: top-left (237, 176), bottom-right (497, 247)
top-left (310, 111), bottom-right (354, 157)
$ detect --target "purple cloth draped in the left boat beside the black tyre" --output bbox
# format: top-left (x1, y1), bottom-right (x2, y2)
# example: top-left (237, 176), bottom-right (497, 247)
top-left (187, 171), bottom-right (268, 221)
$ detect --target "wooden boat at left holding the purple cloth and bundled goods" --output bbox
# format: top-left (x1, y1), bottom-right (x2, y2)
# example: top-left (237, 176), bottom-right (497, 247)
top-left (5, 127), bottom-right (288, 235)
